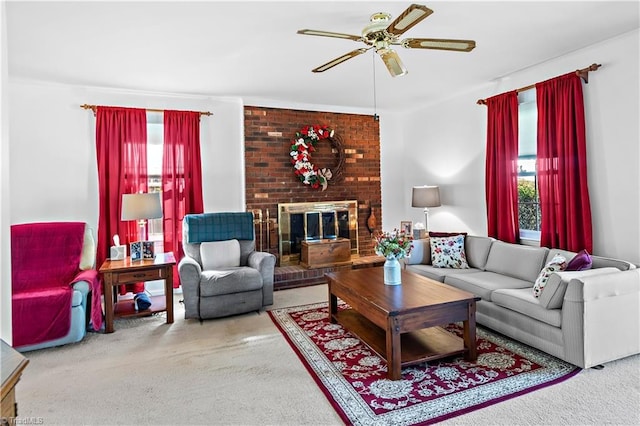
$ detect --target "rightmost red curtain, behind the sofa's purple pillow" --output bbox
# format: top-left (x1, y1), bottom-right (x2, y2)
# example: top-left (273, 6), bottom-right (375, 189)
top-left (536, 72), bottom-right (593, 252)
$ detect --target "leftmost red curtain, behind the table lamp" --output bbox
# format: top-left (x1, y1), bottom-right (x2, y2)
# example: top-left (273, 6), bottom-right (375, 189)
top-left (96, 106), bottom-right (147, 294)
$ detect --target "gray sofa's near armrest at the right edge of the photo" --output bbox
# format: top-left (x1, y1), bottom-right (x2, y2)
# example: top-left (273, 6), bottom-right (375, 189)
top-left (562, 269), bottom-right (640, 368)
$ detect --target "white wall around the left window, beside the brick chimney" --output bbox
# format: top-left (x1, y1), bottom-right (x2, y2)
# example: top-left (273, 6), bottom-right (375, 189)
top-left (10, 81), bottom-right (244, 228)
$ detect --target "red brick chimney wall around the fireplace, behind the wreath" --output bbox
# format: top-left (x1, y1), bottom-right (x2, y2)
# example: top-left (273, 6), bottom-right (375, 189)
top-left (244, 106), bottom-right (382, 256)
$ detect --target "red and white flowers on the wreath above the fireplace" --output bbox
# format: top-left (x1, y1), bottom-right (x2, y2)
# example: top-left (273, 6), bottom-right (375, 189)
top-left (289, 125), bottom-right (333, 191)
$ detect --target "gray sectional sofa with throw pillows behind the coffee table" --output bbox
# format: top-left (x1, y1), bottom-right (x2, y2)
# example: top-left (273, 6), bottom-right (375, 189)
top-left (405, 235), bottom-right (640, 368)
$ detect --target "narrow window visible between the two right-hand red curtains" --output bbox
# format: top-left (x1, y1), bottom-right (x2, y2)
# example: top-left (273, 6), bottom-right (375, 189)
top-left (518, 89), bottom-right (540, 241)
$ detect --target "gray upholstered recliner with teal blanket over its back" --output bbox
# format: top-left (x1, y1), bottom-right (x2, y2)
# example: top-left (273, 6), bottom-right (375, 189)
top-left (178, 212), bottom-right (276, 320)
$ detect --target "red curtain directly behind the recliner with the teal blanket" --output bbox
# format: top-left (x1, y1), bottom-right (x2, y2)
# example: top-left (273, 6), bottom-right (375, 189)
top-left (162, 110), bottom-right (204, 288)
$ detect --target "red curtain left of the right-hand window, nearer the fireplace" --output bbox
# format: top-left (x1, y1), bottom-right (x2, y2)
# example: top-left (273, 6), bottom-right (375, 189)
top-left (485, 91), bottom-right (519, 243)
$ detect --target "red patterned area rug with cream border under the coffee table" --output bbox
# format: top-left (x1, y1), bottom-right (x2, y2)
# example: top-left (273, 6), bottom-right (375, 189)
top-left (269, 302), bottom-right (580, 425)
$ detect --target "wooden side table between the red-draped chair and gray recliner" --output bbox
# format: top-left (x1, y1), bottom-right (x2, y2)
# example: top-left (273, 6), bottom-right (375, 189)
top-left (99, 252), bottom-right (176, 333)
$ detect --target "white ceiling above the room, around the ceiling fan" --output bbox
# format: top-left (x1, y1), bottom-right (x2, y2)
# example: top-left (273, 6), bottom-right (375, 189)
top-left (6, 1), bottom-right (640, 110)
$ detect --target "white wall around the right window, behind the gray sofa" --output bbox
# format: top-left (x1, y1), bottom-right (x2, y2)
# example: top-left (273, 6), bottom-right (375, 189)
top-left (396, 30), bottom-right (640, 264)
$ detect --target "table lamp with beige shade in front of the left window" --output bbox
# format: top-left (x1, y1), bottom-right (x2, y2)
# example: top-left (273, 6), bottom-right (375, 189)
top-left (121, 192), bottom-right (162, 260)
